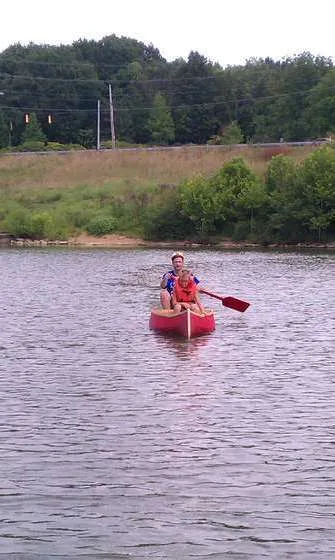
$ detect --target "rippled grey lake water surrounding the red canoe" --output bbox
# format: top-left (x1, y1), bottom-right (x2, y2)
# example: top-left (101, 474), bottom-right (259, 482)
top-left (0, 249), bottom-right (335, 560)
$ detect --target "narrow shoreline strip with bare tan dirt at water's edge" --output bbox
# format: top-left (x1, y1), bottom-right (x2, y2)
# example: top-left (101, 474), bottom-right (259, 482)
top-left (1, 234), bottom-right (335, 250)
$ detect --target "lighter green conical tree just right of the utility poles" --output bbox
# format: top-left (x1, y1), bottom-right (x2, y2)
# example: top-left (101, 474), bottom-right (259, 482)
top-left (148, 93), bottom-right (175, 145)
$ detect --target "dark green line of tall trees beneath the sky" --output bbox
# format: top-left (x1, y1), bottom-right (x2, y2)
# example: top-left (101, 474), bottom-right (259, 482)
top-left (0, 35), bottom-right (335, 148)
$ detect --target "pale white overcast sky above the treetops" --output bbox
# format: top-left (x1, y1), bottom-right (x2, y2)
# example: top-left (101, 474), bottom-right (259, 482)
top-left (0, 0), bottom-right (335, 67)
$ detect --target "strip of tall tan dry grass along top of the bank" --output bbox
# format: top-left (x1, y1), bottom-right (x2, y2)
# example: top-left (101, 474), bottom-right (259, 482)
top-left (0, 146), bottom-right (315, 189)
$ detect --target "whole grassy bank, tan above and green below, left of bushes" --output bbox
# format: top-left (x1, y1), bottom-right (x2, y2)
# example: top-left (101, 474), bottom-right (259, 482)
top-left (0, 145), bottom-right (330, 243)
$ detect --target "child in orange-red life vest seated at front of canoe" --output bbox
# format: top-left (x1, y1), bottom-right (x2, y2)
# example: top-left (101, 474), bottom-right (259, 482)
top-left (171, 270), bottom-right (205, 314)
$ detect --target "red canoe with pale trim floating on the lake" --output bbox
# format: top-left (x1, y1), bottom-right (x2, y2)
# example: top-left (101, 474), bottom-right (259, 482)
top-left (149, 309), bottom-right (215, 338)
